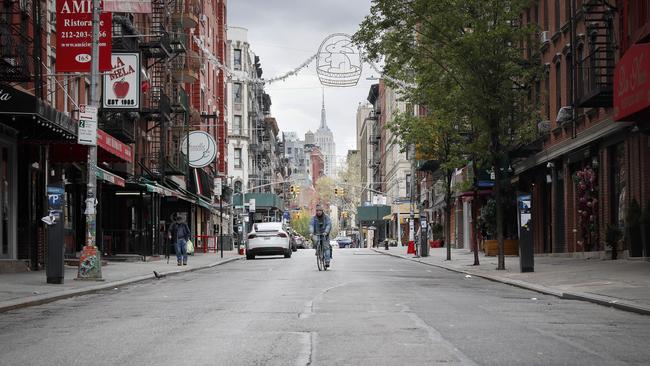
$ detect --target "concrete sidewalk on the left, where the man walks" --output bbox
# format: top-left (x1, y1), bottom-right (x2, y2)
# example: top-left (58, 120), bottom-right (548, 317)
top-left (0, 250), bottom-right (243, 313)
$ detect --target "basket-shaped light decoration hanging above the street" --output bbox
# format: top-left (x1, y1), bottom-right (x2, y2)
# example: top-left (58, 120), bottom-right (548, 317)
top-left (316, 33), bottom-right (361, 87)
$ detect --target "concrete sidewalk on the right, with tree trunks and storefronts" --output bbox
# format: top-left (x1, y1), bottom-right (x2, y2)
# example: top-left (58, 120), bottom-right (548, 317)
top-left (375, 247), bottom-right (650, 315)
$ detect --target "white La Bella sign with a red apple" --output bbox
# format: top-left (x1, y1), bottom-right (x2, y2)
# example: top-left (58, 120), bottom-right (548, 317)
top-left (103, 53), bottom-right (140, 109)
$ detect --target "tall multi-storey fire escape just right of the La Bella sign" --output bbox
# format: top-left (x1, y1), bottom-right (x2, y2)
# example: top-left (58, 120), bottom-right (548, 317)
top-left (140, 0), bottom-right (200, 181)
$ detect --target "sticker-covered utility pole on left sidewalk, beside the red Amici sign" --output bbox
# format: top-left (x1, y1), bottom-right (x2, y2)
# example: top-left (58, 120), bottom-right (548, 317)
top-left (77, 0), bottom-right (102, 281)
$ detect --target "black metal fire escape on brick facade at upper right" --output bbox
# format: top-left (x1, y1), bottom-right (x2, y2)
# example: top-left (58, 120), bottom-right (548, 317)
top-left (577, 0), bottom-right (616, 108)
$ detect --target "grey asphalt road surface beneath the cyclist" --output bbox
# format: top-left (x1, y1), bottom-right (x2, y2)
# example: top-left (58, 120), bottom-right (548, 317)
top-left (0, 249), bottom-right (650, 366)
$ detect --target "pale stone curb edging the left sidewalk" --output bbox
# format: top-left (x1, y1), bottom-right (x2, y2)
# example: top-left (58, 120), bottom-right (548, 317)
top-left (0, 256), bottom-right (243, 313)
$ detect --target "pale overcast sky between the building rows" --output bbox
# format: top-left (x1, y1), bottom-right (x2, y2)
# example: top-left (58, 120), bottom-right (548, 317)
top-left (228, 0), bottom-right (378, 163)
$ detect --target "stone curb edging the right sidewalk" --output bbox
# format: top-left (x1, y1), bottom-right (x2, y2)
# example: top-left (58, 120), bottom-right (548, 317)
top-left (371, 248), bottom-right (650, 315)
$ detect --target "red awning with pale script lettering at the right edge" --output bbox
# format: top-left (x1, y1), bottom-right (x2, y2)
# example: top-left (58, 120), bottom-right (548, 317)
top-left (614, 43), bottom-right (650, 121)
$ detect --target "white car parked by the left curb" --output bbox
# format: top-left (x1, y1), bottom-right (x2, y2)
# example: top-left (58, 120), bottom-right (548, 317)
top-left (246, 222), bottom-right (291, 259)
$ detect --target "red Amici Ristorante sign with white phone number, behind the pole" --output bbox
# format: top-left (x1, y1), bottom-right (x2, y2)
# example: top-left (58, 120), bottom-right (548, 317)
top-left (56, 0), bottom-right (113, 72)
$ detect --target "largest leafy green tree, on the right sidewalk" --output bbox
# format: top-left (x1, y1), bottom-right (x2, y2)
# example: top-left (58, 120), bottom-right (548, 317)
top-left (353, 0), bottom-right (541, 269)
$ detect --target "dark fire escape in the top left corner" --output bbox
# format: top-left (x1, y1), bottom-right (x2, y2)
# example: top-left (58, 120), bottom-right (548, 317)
top-left (0, 0), bottom-right (34, 83)
